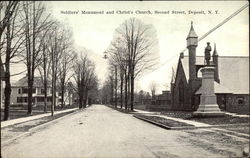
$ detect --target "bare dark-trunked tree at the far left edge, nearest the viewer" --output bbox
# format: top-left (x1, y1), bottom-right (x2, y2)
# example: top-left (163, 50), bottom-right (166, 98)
top-left (0, 2), bottom-right (24, 120)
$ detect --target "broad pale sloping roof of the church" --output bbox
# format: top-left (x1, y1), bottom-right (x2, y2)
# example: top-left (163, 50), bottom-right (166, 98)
top-left (180, 56), bottom-right (249, 94)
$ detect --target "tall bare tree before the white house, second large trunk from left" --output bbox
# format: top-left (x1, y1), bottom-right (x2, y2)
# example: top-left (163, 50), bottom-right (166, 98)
top-left (23, 1), bottom-right (51, 114)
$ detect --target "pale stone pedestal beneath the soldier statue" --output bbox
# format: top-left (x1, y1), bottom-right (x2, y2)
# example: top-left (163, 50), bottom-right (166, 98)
top-left (193, 66), bottom-right (224, 116)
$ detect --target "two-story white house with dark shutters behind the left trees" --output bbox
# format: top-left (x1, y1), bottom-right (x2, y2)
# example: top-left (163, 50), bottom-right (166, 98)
top-left (11, 75), bottom-right (58, 106)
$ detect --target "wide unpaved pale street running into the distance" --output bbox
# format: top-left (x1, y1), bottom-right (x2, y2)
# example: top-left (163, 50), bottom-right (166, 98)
top-left (1, 105), bottom-right (249, 158)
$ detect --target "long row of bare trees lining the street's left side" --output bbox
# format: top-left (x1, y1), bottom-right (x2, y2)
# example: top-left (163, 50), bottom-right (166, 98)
top-left (0, 1), bottom-right (97, 120)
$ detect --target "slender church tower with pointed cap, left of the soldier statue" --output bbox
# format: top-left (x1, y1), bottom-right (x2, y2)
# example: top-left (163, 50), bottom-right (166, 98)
top-left (186, 22), bottom-right (198, 80)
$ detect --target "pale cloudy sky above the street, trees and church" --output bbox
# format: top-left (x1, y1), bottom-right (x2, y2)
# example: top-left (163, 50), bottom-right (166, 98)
top-left (9, 1), bottom-right (249, 93)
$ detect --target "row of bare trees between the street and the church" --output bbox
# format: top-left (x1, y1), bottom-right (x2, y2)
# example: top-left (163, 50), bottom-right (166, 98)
top-left (103, 18), bottom-right (159, 110)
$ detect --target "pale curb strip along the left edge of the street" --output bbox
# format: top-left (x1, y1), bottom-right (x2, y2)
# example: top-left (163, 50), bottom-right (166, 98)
top-left (1, 109), bottom-right (80, 146)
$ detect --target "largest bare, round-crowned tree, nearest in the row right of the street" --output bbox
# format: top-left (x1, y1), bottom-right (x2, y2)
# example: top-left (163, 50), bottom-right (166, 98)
top-left (107, 18), bottom-right (158, 110)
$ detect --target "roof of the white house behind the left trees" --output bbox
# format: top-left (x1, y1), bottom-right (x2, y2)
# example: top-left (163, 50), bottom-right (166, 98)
top-left (13, 76), bottom-right (51, 87)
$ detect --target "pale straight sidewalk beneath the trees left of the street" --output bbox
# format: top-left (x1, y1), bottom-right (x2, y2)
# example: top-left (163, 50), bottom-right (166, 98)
top-left (1, 108), bottom-right (78, 128)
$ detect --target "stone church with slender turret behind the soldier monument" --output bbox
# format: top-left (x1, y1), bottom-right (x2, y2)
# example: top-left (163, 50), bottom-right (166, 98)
top-left (171, 24), bottom-right (249, 113)
